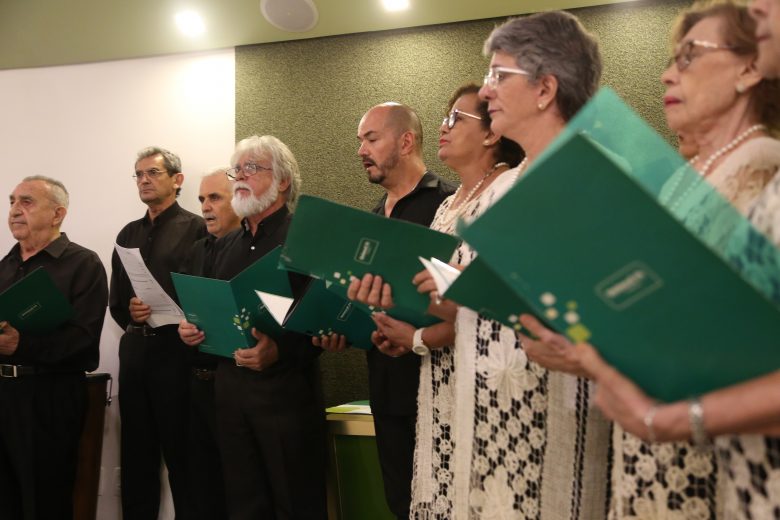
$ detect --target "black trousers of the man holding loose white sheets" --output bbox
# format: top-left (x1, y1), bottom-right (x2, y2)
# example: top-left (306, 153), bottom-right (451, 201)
top-left (119, 328), bottom-right (191, 520)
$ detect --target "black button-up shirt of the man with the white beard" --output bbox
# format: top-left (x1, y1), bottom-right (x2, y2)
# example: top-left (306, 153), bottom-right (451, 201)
top-left (214, 206), bottom-right (322, 407)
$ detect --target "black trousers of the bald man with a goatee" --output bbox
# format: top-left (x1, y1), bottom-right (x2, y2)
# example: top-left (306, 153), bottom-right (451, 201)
top-left (374, 413), bottom-right (417, 520)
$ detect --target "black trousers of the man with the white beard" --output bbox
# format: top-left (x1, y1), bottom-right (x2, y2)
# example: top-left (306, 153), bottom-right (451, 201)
top-left (216, 362), bottom-right (327, 520)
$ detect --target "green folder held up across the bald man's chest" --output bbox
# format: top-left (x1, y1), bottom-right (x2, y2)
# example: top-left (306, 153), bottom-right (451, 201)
top-left (281, 195), bottom-right (458, 326)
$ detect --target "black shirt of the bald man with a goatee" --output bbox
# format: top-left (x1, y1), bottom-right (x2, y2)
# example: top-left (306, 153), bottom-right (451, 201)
top-left (366, 171), bottom-right (456, 415)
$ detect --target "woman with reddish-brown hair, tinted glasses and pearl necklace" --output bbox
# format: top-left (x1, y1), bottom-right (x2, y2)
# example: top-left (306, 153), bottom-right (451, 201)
top-left (521, 3), bottom-right (780, 519)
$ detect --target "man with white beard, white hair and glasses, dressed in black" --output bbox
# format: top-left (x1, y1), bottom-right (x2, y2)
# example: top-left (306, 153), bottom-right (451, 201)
top-left (179, 135), bottom-right (327, 520)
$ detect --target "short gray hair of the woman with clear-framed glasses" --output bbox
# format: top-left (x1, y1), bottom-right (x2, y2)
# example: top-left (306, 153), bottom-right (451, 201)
top-left (483, 11), bottom-right (601, 121)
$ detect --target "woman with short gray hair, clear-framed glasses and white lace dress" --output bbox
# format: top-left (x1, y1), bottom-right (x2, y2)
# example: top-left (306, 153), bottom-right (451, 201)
top-left (412, 12), bottom-right (609, 520)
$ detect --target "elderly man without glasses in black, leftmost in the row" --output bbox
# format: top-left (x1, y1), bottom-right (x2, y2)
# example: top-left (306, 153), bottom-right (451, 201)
top-left (0, 176), bottom-right (108, 520)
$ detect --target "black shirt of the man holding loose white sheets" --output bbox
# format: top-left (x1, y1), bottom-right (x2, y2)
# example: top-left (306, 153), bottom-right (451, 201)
top-left (109, 202), bottom-right (206, 329)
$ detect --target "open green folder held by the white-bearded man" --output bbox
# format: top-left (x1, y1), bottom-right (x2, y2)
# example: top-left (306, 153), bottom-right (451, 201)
top-left (171, 247), bottom-right (292, 357)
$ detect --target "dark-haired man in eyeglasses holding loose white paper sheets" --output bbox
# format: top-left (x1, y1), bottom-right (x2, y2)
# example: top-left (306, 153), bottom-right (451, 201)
top-left (109, 147), bottom-right (206, 520)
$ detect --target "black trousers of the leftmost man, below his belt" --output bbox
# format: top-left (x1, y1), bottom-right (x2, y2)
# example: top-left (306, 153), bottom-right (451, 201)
top-left (0, 373), bottom-right (87, 520)
